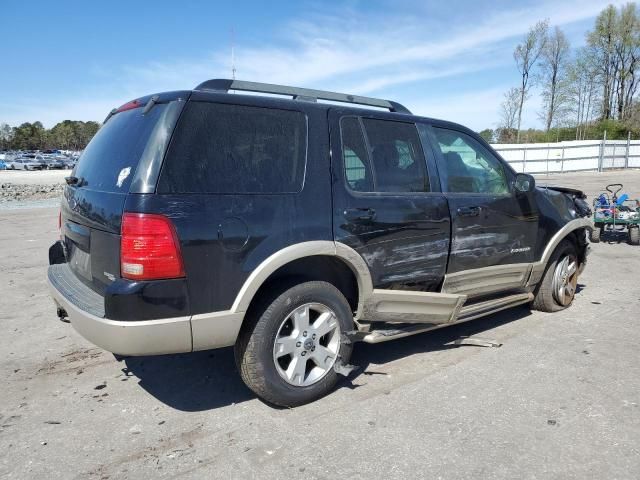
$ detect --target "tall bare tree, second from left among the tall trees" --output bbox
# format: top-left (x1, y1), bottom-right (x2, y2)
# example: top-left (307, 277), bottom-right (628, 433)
top-left (540, 27), bottom-right (570, 132)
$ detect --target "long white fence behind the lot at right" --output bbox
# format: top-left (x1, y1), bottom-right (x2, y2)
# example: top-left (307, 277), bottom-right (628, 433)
top-left (492, 140), bottom-right (640, 173)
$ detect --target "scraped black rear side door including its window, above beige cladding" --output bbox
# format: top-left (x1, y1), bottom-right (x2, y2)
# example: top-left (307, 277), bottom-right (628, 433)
top-left (329, 109), bottom-right (450, 292)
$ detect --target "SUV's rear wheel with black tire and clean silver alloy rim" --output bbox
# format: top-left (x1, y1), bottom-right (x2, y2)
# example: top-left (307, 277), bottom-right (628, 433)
top-left (235, 281), bottom-right (353, 407)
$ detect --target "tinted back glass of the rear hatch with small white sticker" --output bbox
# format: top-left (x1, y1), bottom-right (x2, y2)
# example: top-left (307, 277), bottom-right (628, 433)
top-left (74, 104), bottom-right (167, 193)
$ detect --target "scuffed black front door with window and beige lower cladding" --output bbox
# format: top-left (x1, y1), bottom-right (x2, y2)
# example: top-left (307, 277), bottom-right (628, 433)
top-left (424, 126), bottom-right (538, 296)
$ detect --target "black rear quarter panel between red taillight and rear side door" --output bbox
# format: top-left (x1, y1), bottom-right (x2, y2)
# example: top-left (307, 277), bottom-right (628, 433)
top-left (125, 108), bottom-right (332, 315)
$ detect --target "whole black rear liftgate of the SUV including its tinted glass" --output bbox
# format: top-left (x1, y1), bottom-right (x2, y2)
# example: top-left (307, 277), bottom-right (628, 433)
top-left (60, 92), bottom-right (189, 294)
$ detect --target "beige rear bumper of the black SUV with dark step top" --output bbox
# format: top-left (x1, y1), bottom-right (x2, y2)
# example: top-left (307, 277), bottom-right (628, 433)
top-left (47, 263), bottom-right (244, 355)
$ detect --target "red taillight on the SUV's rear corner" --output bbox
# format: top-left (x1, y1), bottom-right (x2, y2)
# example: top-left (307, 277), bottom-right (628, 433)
top-left (120, 213), bottom-right (184, 280)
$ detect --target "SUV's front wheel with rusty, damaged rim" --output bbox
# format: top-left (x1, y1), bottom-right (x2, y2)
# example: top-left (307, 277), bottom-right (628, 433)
top-left (531, 240), bottom-right (580, 312)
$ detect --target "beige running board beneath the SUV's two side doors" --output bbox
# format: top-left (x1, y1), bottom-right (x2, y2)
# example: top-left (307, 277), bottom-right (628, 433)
top-left (354, 293), bottom-right (533, 343)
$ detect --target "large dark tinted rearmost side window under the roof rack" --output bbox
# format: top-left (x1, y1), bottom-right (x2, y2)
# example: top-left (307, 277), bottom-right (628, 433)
top-left (158, 102), bottom-right (307, 194)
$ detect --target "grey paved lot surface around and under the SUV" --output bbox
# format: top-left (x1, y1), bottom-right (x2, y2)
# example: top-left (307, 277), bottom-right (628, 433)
top-left (0, 171), bottom-right (640, 479)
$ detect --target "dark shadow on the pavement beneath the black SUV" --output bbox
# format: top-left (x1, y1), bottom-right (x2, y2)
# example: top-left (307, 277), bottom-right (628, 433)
top-left (122, 307), bottom-right (531, 412)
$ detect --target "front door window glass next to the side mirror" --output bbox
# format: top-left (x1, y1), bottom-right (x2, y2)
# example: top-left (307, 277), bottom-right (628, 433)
top-left (434, 128), bottom-right (509, 195)
